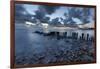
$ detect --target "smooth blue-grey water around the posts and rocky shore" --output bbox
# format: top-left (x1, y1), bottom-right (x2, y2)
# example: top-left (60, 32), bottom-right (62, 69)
top-left (15, 24), bottom-right (94, 64)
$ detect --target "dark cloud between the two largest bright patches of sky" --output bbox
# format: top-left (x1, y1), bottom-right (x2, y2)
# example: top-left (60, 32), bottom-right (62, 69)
top-left (34, 5), bottom-right (59, 22)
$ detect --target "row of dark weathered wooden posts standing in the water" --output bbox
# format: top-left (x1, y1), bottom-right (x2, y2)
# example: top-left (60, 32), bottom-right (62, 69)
top-left (34, 31), bottom-right (94, 41)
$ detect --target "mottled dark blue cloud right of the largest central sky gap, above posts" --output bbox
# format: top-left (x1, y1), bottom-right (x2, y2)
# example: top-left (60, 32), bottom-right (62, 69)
top-left (64, 7), bottom-right (91, 23)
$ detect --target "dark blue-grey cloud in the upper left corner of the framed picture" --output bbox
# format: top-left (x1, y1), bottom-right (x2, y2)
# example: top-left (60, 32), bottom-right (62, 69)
top-left (15, 4), bottom-right (33, 23)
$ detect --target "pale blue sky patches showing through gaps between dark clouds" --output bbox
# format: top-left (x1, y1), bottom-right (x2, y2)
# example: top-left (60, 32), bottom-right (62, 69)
top-left (16, 4), bottom-right (94, 24)
